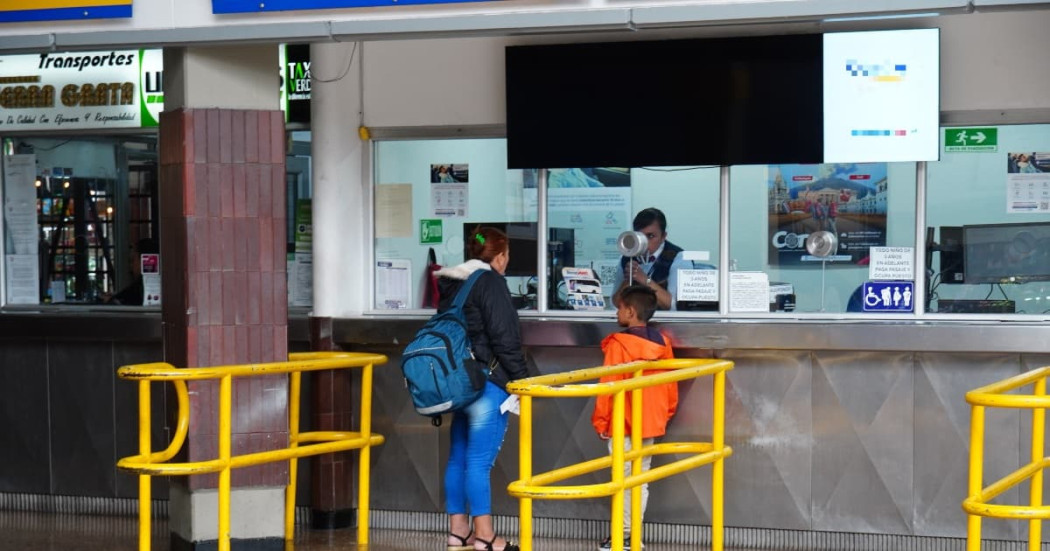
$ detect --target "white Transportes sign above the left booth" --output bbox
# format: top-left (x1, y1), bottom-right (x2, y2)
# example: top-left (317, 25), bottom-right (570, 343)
top-left (0, 49), bottom-right (164, 132)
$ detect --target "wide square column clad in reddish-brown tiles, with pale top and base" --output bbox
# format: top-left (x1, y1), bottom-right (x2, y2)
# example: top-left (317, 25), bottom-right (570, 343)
top-left (160, 45), bottom-right (288, 551)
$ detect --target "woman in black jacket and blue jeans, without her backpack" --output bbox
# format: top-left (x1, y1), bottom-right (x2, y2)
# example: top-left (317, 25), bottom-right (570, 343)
top-left (435, 227), bottom-right (527, 551)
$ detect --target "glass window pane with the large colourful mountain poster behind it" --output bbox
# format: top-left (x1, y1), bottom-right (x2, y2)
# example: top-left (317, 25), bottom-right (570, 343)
top-left (730, 163), bottom-right (916, 313)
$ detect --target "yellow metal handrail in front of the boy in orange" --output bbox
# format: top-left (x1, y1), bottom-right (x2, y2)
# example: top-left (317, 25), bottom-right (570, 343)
top-left (507, 359), bottom-right (733, 551)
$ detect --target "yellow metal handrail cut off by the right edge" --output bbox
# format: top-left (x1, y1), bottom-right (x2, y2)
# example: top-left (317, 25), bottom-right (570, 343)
top-left (963, 367), bottom-right (1050, 551)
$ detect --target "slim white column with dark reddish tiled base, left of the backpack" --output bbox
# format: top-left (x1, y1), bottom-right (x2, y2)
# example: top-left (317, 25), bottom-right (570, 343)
top-left (310, 39), bottom-right (372, 528)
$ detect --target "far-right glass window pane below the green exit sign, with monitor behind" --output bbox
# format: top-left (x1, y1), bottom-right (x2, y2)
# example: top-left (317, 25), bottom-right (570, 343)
top-left (926, 125), bottom-right (1050, 317)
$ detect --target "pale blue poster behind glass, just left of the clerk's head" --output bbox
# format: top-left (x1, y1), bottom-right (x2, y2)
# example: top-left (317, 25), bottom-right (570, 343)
top-left (523, 167), bottom-right (634, 285)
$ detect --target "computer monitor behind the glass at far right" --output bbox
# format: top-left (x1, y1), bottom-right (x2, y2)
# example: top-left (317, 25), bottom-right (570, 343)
top-left (963, 222), bottom-right (1050, 283)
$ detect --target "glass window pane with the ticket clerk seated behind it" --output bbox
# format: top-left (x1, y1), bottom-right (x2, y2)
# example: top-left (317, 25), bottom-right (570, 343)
top-left (547, 167), bottom-right (719, 312)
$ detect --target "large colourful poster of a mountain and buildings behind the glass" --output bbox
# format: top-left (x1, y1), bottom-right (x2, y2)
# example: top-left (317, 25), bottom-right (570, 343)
top-left (768, 163), bottom-right (887, 266)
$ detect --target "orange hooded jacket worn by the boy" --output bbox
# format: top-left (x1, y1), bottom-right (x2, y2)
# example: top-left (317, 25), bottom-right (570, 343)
top-left (591, 333), bottom-right (678, 438)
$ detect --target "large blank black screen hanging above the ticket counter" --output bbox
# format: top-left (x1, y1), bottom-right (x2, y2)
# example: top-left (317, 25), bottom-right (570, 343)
top-left (506, 35), bottom-right (823, 168)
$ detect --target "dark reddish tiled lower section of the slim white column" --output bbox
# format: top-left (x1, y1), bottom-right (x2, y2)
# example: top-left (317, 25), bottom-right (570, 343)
top-left (310, 317), bottom-right (357, 530)
